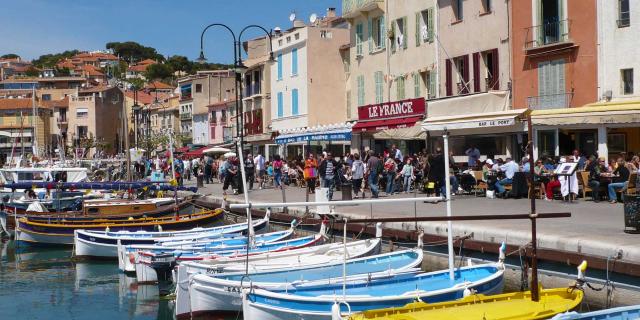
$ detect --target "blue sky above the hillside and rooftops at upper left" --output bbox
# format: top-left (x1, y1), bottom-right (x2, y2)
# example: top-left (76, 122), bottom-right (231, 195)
top-left (0, 0), bottom-right (342, 63)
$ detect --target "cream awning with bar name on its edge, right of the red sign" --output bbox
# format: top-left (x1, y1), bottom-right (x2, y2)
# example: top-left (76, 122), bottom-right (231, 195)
top-left (422, 109), bottom-right (527, 133)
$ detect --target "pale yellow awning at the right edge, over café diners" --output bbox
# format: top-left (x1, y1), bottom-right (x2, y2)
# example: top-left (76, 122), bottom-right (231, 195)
top-left (531, 100), bottom-right (640, 126)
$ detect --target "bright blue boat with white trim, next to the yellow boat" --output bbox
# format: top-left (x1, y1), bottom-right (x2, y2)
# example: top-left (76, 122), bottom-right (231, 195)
top-left (242, 262), bottom-right (504, 320)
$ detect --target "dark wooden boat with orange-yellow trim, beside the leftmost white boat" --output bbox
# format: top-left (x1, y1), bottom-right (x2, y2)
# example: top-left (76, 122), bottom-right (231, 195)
top-left (16, 209), bottom-right (224, 245)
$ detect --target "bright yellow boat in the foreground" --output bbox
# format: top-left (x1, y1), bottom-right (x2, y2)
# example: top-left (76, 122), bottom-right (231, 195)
top-left (349, 262), bottom-right (588, 320)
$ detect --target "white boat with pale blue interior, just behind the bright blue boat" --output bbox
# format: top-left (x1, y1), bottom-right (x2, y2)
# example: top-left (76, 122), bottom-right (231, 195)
top-left (185, 249), bottom-right (423, 316)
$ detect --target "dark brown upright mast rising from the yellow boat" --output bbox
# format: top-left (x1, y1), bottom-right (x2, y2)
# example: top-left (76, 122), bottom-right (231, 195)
top-left (527, 114), bottom-right (540, 302)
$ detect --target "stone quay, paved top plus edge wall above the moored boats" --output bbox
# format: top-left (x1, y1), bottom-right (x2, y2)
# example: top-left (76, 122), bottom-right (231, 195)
top-left (192, 183), bottom-right (640, 277)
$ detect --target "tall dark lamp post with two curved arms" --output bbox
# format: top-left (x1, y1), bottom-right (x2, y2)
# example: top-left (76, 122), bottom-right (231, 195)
top-left (196, 23), bottom-right (273, 156)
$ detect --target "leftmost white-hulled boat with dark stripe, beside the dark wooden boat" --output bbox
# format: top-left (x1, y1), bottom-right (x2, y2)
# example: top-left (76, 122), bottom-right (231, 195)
top-left (74, 210), bottom-right (269, 260)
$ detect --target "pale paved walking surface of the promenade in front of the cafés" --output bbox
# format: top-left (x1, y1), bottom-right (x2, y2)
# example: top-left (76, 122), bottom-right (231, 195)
top-left (182, 181), bottom-right (640, 264)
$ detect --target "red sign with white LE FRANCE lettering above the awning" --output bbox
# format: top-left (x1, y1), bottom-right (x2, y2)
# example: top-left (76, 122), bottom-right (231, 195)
top-left (358, 98), bottom-right (425, 121)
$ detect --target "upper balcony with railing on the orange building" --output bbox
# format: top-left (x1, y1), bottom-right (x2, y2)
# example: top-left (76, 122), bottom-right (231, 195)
top-left (524, 20), bottom-right (574, 55)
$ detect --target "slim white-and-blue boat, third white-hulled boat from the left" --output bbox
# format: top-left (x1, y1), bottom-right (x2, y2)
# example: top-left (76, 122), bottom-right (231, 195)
top-left (135, 228), bottom-right (327, 282)
